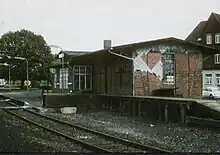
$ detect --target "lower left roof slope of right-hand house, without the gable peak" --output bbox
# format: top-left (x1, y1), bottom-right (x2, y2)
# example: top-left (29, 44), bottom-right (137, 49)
top-left (186, 21), bottom-right (207, 42)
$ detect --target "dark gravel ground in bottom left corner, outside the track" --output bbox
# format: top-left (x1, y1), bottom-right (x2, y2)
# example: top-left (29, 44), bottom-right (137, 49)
top-left (0, 110), bottom-right (88, 152)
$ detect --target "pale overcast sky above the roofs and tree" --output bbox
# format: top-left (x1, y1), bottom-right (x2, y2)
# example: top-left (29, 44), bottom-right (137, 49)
top-left (0, 0), bottom-right (220, 53)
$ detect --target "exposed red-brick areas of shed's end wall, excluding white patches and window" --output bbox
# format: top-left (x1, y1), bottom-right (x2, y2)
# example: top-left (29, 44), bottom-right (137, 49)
top-left (134, 46), bottom-right (202, 98)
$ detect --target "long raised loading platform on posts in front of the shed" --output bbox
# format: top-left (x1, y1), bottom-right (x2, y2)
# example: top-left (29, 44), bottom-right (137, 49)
top-left (40, 93), bottom-right (220, 123)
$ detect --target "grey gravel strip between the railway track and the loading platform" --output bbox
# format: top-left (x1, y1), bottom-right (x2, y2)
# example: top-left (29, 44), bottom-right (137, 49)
top-left (46, 112), bottom-right (220, 152)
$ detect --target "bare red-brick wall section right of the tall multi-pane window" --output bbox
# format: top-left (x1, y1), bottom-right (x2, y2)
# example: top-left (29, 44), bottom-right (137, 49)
top-left (176, 52), bottom-right (202, 98)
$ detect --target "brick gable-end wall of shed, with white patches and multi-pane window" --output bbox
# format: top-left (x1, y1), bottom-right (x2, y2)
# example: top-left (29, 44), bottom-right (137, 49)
top-left (133, 44), bottom-right (202, 97)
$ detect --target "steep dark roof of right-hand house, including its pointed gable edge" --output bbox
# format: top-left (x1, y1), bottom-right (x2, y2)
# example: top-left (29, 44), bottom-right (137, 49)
top-left (185, 12), bottom-right (220, 42)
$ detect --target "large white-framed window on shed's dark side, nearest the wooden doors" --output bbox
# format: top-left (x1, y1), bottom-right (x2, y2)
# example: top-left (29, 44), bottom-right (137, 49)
top-left (73, 66), bottom-right (92, 90)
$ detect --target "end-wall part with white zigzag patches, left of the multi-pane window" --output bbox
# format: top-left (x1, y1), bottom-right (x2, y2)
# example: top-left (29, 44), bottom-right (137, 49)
top-left (134, 44), bottom-right (166, 95)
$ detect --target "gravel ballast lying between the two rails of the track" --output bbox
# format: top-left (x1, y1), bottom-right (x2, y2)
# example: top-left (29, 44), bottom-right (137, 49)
top-left (14, 109), bottom-right (145, 152)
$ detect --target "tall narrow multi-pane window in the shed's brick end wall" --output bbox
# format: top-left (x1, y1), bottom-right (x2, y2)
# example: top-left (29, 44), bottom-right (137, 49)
top-left (162, 53), bottom-right (175, 84)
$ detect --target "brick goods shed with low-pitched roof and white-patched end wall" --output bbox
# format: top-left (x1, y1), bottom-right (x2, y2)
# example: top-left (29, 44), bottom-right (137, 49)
top-left (61, 38), bottom-right (215, 98)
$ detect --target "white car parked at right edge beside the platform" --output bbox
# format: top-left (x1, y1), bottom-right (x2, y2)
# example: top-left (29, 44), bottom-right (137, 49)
top-left (202, 87), bottom-right (220, 99)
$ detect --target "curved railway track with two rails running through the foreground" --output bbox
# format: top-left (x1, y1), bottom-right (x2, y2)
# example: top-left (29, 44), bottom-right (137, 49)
top-left (1, 97), bottom-right (172, 153)
